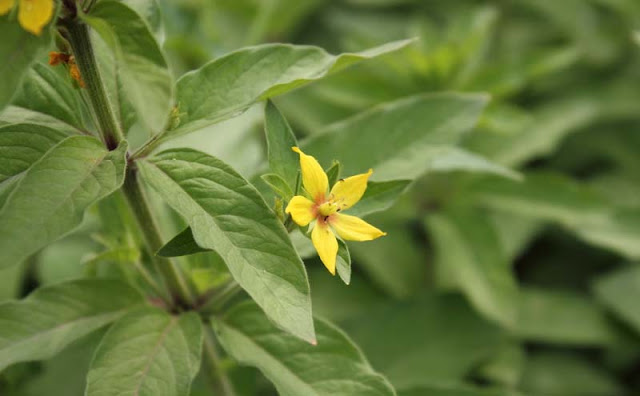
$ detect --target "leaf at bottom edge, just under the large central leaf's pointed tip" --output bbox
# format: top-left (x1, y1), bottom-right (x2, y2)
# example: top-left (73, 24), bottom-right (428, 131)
top-left (213, 302), bottom-right (395, 396)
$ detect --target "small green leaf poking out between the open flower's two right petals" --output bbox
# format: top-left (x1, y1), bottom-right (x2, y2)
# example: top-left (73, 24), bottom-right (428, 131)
top-left (346, 180), bottom-right (411, 217)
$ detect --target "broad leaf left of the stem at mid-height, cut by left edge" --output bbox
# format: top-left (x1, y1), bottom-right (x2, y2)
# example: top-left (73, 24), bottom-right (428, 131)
top-left (0, 136), bottom-right (127, 267)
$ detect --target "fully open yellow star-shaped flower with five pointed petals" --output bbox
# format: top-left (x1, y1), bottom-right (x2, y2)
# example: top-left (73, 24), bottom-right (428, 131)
top-left (285, 147), bottom-right (387, 275)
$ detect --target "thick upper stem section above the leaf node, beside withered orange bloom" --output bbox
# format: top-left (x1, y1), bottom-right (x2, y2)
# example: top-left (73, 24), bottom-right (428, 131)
top-left (65, 20), bottom-right (124, 150)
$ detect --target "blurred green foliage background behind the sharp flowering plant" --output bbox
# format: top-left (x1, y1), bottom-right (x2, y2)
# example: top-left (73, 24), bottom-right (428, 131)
top-left (0, 0), bottom-right (640, 396)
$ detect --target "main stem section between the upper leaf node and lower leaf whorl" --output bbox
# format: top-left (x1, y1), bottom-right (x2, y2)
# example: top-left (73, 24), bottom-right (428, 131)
top-left (122, 166), bottom-right (196, 307)
